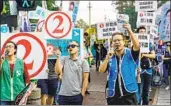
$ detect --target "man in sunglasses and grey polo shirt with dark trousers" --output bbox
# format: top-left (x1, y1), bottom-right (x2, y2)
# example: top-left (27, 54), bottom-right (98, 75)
top-left (55, 41), bottom-right (90, 105)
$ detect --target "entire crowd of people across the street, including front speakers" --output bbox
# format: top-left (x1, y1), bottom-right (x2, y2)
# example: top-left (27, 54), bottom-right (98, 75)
top-left (0, 24), bottom-right (171, 105)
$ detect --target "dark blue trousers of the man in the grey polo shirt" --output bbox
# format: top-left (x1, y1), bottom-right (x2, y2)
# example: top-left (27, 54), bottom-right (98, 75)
top-left (59, 94), bottom-right (83, 105)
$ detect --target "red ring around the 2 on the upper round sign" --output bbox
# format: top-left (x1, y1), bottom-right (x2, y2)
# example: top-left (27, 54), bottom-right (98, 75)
top-left (45, 11), bottom-right (72, 38)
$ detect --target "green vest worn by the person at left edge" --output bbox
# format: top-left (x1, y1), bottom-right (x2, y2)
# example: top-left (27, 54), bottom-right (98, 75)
top-left (0, 58), bottom-right (25, 101)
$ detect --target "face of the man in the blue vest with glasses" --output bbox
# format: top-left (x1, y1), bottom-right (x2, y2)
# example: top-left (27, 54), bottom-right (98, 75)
top-left (112, 35), bottom-right (125, 50)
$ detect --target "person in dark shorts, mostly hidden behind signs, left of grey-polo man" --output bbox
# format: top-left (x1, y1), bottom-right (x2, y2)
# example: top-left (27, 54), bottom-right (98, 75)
top-left (37, 48), bottom-right (61, 105)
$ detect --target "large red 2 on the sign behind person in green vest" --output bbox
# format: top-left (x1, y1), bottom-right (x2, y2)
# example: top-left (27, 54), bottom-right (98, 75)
top-left (17, 40), bottom-right (34, 70)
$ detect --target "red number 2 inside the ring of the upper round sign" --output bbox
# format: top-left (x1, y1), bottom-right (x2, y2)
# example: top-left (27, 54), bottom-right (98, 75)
top-left (53, 15), bottom-right (64, 33)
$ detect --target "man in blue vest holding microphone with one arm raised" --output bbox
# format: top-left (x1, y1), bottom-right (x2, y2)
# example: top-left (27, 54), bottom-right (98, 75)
top-left (99, 24), bottom-right (140, 105)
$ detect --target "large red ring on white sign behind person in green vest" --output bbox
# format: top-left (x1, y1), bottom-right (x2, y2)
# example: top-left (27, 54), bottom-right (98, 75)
top-left (2, 32), bottom-right (47, 78)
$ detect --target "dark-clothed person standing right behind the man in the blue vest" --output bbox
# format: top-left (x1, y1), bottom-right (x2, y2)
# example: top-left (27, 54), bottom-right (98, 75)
top-left (137, 26), bottom-right (155, 105)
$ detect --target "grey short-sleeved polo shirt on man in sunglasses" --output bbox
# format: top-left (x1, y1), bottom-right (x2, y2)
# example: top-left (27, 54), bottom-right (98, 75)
top-left (59, 56), bottom-right (90, 96)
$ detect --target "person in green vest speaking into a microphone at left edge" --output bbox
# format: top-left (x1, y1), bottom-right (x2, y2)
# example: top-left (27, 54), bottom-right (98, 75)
top-left (0, 41), bottom-right (30, 105)
